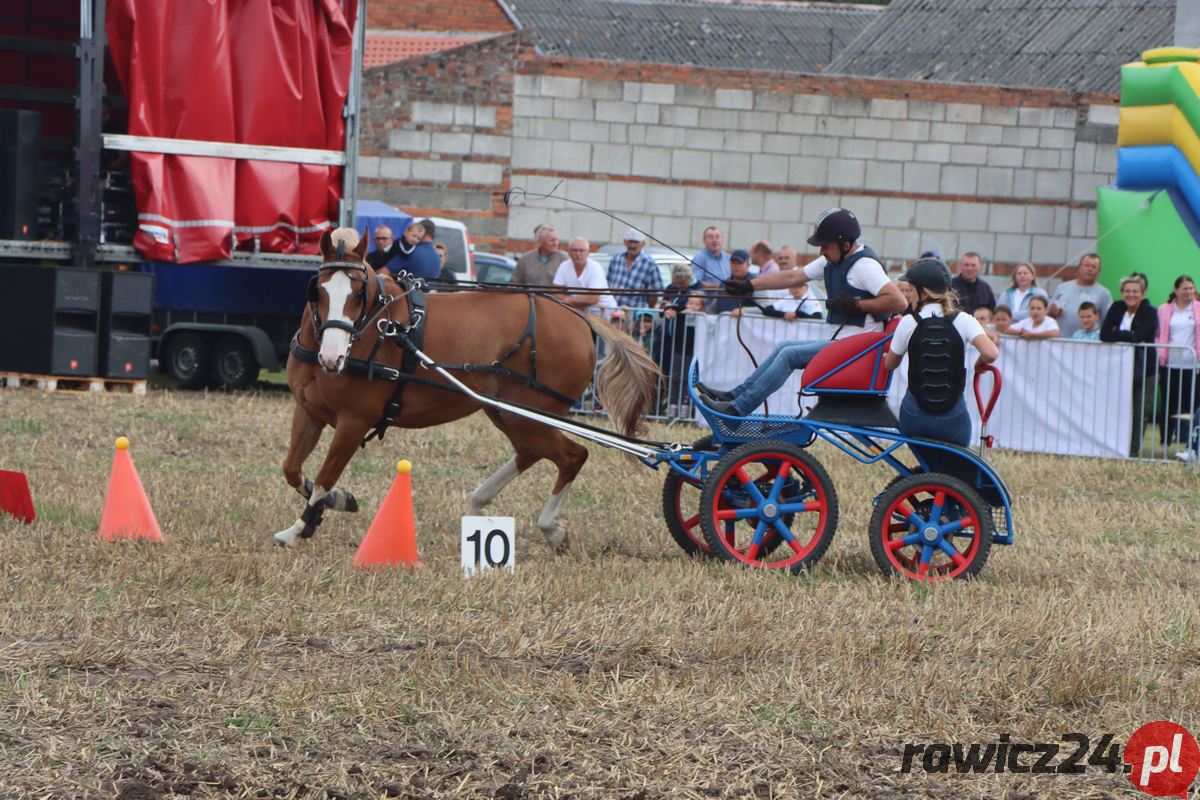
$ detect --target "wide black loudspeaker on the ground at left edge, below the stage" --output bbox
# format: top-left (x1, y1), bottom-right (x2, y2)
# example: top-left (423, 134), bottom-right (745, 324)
top-left (0, 264), bottom-right (100, 377)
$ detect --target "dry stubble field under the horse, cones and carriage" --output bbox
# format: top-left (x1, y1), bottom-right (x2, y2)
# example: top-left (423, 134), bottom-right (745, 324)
top-left (0, 390), bottom-right (1200, 799)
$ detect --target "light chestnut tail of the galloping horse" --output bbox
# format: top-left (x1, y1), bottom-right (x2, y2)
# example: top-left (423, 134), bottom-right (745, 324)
top-left (581, 314), bottom-right (662, 437)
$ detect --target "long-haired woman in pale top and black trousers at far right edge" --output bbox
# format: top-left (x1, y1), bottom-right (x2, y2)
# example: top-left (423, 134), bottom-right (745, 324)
top-left (1154, 275), bottom-right (1200, 455)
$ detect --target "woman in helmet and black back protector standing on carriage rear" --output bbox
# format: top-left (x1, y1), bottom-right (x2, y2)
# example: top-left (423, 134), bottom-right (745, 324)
top-left (883, 258), bottom-right (1000, 447)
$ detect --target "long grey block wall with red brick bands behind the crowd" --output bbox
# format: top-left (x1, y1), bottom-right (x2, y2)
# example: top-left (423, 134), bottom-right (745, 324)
top-left (364, 36), bottom-right (1116, 271)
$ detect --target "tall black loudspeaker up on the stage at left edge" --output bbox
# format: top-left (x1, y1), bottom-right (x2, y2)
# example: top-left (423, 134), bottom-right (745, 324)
top-left (0, 108), bottom-right (42, 239)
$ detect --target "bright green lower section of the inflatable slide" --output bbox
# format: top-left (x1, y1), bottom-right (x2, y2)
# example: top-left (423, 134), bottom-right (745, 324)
top-left (1096, 187), bottom-right (1200, 306)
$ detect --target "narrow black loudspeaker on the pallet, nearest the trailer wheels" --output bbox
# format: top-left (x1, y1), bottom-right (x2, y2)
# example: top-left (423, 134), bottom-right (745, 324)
top-left (100, 272), bottom-right (154, 379)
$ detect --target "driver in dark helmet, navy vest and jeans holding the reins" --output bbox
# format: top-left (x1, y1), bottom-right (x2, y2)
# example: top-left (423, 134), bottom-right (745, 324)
top-left (697, 209), bottom-right (907, 416)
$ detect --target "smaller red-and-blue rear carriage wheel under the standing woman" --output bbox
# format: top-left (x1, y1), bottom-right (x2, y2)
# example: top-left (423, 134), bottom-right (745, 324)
top-left (870, 473), bottom-right (991, 582)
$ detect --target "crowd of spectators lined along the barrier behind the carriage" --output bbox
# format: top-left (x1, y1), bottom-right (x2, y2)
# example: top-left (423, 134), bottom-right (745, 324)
top-left (480, 224), bottom-right (1200, 461)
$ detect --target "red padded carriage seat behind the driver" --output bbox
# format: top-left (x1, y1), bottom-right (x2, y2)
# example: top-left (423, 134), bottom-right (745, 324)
top-left (800, 317), bottom-right (900, 428)
